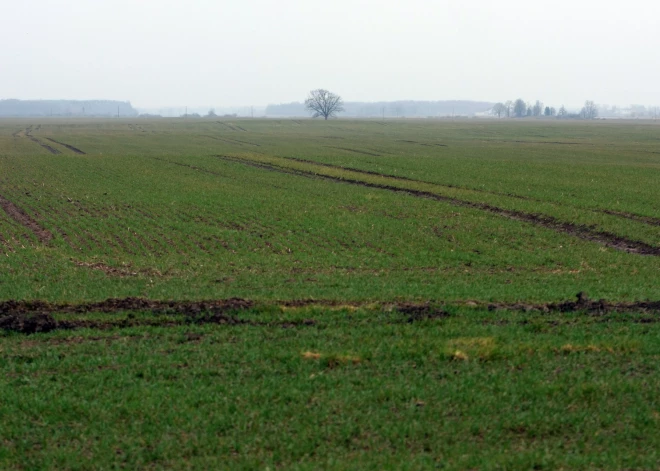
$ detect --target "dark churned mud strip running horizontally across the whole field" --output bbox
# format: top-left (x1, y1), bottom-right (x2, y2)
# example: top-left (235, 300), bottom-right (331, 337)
top-left (0, 293), bottom-right (660, 334)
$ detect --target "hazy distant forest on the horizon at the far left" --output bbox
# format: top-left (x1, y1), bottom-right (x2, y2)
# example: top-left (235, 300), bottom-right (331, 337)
top-left (0, 100), bottom-right (138, 117)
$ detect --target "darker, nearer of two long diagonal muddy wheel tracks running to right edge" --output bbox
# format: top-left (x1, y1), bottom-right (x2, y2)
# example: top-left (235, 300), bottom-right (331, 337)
top-left (215, 155), bottom-right (660, 257)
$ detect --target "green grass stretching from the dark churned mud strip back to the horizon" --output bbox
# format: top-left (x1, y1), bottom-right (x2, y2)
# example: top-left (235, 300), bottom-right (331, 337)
top-left (0, 120), bottom-right (660, 301)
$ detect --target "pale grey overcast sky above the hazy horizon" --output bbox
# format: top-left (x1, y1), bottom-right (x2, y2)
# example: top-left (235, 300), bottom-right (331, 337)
top-left (0, 0), bottom-right (660, 107)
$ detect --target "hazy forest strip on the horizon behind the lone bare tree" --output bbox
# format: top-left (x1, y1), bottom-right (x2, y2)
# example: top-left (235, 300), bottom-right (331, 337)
top-left (266, 100), bottom-right (494, 118)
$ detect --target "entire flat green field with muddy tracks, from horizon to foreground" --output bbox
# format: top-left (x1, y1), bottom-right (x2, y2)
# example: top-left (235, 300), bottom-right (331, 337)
top-left (0, 118), bottom-right (660, 469)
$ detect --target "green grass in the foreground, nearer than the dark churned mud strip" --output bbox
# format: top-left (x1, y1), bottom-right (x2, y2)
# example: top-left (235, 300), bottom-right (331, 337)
top-left (0, 306), bottom-right (660, 469)
